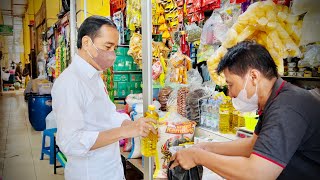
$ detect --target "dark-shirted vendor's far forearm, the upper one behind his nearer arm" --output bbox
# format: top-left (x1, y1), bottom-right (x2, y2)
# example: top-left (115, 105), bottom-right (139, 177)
top-left (205, 136), bottom-right (256, 157)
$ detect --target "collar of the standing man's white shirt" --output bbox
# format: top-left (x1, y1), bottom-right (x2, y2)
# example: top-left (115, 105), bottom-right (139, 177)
top-left (74, 54), bottom-right (102, 79)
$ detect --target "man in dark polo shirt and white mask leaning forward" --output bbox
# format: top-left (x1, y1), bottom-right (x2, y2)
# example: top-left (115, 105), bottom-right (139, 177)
top-left (171, 41), bottom-right (320, 180)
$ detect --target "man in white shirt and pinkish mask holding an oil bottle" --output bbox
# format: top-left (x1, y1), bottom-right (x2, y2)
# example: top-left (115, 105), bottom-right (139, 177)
top-left (52, 16), bottom-right (156, 180)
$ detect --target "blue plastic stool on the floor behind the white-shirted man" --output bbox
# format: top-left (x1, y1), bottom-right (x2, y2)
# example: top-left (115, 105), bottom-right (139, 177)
top-left (40, 128), bottom-right (57, 164)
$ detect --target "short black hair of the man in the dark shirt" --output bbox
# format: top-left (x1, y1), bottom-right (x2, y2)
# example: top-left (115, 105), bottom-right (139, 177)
top-left (217, 41), bottom-right (278, 79)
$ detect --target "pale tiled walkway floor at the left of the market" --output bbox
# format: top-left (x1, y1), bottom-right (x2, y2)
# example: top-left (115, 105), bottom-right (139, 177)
top-left (0, 91), bottom-right (64, 180)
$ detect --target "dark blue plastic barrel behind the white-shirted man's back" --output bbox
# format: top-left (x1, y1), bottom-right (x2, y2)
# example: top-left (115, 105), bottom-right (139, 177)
top-left (28, 95), bottom-right (52, 131)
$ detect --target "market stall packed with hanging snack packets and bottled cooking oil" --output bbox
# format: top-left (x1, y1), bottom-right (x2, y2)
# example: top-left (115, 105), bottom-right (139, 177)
top-left (109, 0), bottom-right (320, 179)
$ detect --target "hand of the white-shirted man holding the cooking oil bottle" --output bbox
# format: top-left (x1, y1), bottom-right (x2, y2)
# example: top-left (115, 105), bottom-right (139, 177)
top-left (123, 118), bottom-right (157, 138)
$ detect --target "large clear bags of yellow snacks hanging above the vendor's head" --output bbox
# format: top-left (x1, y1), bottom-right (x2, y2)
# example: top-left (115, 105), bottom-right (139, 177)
top-left (208, 1), bottom-right (302, 85)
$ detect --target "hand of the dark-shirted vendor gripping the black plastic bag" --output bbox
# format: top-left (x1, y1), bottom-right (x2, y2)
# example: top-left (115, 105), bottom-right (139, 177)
top-left (170, 147), bottom-right (203, 170)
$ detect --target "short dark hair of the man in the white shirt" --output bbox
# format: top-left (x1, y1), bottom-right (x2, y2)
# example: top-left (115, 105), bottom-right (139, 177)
top-left (77, 16), bottom-right (117, 49)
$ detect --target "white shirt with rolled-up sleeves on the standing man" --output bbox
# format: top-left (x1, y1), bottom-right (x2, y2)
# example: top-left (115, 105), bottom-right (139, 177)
top-left (52, 55), bottom-right (129, 180)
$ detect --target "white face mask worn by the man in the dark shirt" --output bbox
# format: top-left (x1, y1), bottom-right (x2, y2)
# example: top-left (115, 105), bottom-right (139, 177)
top-left (232, 76), bottom-right (258, 112)
